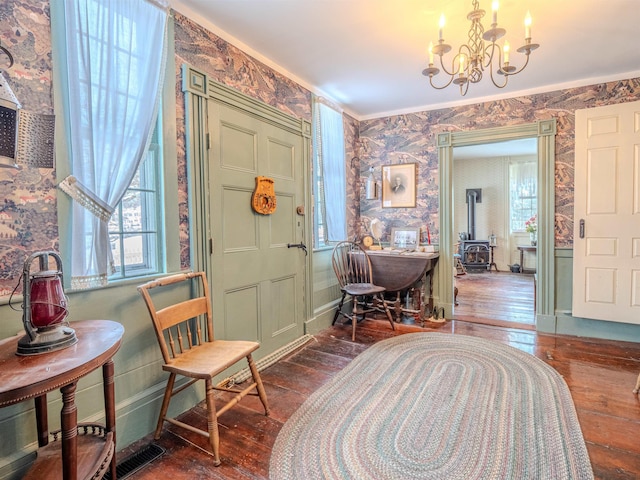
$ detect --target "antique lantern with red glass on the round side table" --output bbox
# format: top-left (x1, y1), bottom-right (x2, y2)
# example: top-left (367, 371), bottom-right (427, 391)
top-left (17, 252), bottom-right (78, 355)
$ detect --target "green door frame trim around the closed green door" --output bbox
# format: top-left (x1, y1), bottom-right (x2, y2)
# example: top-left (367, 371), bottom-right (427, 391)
top-left (182, 64), bottom-right (313, 323)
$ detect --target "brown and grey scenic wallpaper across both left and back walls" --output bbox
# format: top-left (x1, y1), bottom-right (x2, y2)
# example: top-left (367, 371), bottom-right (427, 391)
top-left (0, 0), bottom-right (640, 297)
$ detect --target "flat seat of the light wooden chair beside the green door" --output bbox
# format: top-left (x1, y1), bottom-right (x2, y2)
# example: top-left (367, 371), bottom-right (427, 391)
top-left (162, 340), bottom-right (260, 379)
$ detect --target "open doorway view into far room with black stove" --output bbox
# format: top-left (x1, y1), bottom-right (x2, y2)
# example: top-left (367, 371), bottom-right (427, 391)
top-left (453, 138), bottom-right (538, 329)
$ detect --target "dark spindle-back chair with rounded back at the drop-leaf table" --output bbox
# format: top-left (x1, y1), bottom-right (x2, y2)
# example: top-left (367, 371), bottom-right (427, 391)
top-left (331, 241), bottom-right (396, 340)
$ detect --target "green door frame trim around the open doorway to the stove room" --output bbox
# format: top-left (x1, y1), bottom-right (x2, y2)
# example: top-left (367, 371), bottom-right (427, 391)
top-left (437, 118), bottom-right (556, 325)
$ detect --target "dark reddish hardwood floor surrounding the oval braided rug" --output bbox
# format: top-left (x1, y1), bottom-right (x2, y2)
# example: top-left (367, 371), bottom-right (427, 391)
top-left (119, 319), bottom-right (640, 480)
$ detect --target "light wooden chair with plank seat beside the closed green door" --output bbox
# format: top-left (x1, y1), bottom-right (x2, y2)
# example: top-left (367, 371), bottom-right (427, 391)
top-left (138, 272), bottom-right (269, 466)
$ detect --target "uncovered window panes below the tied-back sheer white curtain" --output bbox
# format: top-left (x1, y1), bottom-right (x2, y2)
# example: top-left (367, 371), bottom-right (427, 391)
top-left (109, 122), bottom-right (162, 280)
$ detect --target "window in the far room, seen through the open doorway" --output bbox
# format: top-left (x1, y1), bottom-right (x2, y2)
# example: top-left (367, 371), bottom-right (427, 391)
top-left (509, 161), bottom-right (538, 233)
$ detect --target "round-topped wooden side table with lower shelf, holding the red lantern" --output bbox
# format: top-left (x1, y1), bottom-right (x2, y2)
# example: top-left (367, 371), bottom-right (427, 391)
top-left (0, 320), bottom-right (124, 480)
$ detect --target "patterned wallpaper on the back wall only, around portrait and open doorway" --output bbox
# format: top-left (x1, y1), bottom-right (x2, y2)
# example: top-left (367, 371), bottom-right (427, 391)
top-left (358, 78), bottom-right (640, 247)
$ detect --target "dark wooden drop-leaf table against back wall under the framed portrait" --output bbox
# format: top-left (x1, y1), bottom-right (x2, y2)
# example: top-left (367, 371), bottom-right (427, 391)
top-left (367, 250), bottom-right (440, 321)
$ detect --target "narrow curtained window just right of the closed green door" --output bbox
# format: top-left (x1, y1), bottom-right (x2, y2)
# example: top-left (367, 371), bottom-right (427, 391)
top-left (313, 97), bottom-right (347, 248)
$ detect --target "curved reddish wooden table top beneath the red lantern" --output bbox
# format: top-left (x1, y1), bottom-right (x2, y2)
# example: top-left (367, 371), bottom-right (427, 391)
top-left (0, 320), bottom-right (124, 407)
